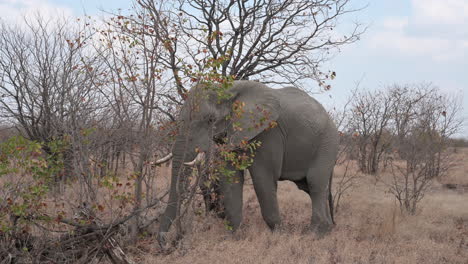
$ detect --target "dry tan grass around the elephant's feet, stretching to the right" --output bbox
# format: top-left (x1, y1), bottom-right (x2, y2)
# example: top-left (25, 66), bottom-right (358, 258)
top-left (132, 150), bottom-right (468, 264)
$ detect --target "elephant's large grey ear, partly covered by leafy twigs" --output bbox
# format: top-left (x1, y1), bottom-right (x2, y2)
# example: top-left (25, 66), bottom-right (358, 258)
top-left (228, 81), bottom-right (280, 146)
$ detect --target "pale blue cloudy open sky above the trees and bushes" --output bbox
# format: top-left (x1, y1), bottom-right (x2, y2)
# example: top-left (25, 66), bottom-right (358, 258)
top-left (0, 0), bottom-right (468, 138)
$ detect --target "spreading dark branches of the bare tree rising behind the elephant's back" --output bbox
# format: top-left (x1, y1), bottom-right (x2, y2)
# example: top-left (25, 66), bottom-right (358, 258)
top-left (131, 0), bottom-right (364, 96)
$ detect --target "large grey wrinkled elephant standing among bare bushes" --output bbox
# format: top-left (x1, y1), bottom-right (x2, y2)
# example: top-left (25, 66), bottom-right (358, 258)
top-left (158, 81), bottom-right (338, 244)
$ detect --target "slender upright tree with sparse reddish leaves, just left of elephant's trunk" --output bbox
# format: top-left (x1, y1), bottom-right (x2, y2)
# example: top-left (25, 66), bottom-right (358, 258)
top-left (96, 16), bottom-right (179, 239)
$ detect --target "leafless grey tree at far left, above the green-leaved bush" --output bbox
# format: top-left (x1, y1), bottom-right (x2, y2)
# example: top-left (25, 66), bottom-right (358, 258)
top-left (0, 15), bottom-right (105, 194)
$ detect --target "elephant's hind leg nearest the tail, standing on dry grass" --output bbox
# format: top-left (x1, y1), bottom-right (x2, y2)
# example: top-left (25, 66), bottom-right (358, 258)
top-left (307, 160), bottom-right (333, 236)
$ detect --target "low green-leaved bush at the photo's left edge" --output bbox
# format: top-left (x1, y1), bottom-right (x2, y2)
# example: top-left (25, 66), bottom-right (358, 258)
top-left (0, 136), bottom-right (63, 234)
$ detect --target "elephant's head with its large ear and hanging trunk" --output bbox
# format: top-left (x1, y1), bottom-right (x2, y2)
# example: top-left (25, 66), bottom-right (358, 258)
top-left (160, 81), bottom-right (280, 243)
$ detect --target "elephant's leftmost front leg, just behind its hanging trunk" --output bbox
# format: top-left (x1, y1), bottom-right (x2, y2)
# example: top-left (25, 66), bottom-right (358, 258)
top-left (220, 171), bottom-right (244, 231)
